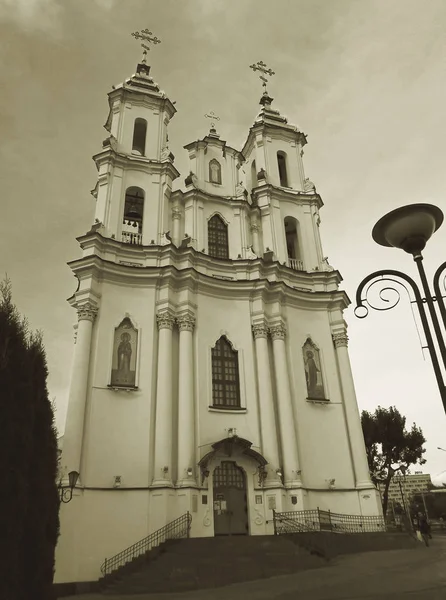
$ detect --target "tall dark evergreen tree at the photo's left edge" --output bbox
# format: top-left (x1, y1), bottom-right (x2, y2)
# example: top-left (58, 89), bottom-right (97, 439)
top-left (0, 281), bottom-right (59, 600)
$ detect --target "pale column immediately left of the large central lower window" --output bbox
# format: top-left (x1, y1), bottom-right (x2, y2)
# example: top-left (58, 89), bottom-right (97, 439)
top-left (177, 314), bottom-right (196, 486)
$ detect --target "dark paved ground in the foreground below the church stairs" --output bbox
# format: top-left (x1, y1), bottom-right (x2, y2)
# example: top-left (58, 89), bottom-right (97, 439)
top-left (67, 536), bottom-right (446, 600)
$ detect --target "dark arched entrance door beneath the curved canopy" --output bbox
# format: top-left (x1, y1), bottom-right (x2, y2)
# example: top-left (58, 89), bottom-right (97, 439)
top-left (213, 461), bottom-right (248, 535)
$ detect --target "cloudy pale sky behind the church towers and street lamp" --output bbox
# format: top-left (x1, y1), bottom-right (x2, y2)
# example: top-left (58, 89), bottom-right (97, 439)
top-left (0, 0), bottom-right (446, 481)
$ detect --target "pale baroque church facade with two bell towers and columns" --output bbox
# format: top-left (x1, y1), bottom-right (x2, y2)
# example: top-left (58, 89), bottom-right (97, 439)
top-left (55, 54), bottom-right (381, 582)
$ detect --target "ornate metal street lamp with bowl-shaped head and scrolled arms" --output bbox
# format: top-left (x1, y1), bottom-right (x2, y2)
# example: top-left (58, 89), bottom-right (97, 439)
top-left (355, 204), bottom-right (446, 412)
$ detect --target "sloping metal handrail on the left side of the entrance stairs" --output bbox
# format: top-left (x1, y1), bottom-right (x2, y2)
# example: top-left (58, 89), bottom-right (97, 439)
top-left (101, 511), bottom-right (192, 576)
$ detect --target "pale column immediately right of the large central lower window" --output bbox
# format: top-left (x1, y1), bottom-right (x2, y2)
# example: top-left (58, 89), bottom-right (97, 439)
top-left (252, 323), bottom-right (280, 487)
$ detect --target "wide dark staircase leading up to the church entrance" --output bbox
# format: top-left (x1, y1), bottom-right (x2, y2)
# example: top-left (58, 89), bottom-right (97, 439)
top-left (102, 535), bottom-right (326, 595)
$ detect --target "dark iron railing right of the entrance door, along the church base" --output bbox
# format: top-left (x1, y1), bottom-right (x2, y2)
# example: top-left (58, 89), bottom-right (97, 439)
top-left (273, 508), bottom-right (386, 535)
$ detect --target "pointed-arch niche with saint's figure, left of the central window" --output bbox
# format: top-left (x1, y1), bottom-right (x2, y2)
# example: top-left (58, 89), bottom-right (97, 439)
top-left (111, 317), bottom-right (138, 387)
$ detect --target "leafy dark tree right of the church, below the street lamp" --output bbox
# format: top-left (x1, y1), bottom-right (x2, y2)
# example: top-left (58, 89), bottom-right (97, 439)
top-left (361, 406), bottom-right (426, 516)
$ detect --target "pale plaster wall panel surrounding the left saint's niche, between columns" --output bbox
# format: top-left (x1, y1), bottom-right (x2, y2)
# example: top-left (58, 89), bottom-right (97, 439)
top-left (82, 283), bottom-right (157, 487)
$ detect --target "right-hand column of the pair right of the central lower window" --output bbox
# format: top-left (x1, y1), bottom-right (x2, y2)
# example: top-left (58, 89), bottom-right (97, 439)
top-left (270, 323), bottom-right (302, 487)
